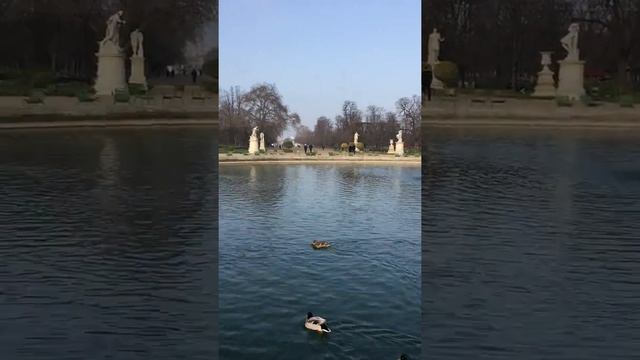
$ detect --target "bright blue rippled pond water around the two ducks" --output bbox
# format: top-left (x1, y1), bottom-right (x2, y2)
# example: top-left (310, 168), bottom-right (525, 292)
top-left (219, 164), bottom-right (421, 359)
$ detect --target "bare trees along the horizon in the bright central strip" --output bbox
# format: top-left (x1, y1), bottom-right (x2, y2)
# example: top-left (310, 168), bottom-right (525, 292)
top-left (219, 83), bottom-right (421, 150)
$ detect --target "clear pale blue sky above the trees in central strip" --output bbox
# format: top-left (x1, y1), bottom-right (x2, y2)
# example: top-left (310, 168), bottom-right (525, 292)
top-left (219, 0), bottom-right (421, 134)
